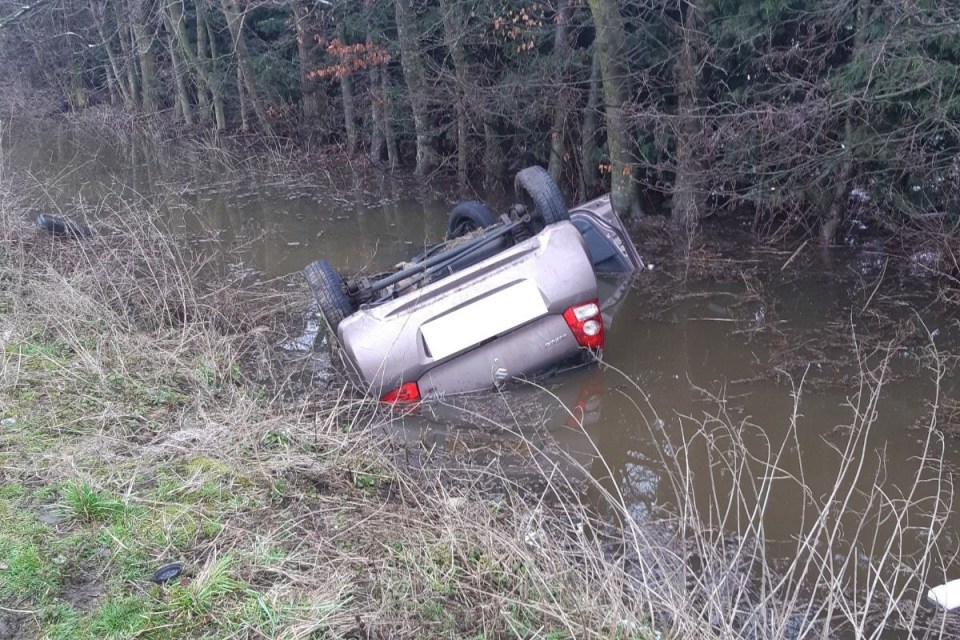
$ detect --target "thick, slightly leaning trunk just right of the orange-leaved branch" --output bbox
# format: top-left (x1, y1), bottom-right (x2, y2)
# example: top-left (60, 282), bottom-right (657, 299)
top-left (393, 0), bottom-right (437, 176)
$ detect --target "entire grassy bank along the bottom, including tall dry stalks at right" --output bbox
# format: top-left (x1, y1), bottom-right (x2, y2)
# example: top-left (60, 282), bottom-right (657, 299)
top-left (0, 170), bottom-right (953, 640)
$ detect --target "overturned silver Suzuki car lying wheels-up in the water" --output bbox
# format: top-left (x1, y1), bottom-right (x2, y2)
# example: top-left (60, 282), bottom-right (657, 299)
top-left (304, 167), bottom-right (641, 402)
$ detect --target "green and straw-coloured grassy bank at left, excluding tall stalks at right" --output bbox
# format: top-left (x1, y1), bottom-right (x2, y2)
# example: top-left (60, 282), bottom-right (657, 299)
top-left (0, 185), bottom-right (660, 639)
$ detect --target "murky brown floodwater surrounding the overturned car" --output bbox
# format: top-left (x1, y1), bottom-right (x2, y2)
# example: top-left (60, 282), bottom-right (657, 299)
top-left (4, 120), bottom-right (960, 624)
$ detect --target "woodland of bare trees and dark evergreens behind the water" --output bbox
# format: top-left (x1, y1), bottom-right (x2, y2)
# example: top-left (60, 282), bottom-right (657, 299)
top-left (0, 0), bottom-right (960, 244)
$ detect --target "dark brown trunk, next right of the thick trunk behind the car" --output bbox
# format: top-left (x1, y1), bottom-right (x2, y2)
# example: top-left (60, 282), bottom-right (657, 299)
top-left (671, 0), bottom-right (708, 236)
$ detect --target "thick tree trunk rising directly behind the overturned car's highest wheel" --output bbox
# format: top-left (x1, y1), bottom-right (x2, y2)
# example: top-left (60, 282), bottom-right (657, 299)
top-left (589, 0), bottom-right (642, 217)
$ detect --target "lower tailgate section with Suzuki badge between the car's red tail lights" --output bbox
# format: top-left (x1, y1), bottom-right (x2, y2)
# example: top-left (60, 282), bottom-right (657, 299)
top-left (417, 315), bottom-right (582, 399)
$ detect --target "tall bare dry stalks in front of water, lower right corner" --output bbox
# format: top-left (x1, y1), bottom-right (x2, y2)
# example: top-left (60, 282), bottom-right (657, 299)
top-left (600, 352), bottom-right (957, 638)
